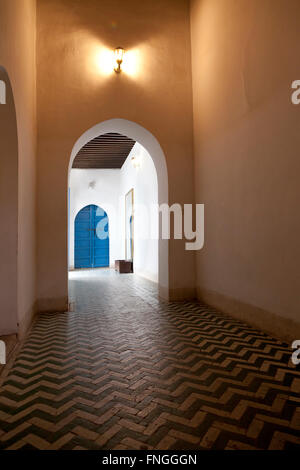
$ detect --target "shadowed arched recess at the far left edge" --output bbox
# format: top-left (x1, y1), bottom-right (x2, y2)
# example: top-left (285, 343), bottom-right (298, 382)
top-left (0, 65), bottom-right (18, 335)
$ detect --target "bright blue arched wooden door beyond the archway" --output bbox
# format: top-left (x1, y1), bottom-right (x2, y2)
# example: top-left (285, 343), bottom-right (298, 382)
top-left (75, 204), bottom-right (109, 268)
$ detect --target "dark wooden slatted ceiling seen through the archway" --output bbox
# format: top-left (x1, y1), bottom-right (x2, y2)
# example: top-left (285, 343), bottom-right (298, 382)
top-left (73, 132), bottom-right (135, 168)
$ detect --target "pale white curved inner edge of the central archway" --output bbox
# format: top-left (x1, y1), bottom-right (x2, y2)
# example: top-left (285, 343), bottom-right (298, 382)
top-left (68, 119), bottom-right (169, 298)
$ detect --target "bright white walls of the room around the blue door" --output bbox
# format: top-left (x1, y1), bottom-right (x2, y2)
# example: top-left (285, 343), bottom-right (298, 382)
top-left (69, 143), bottom-right (158, 282)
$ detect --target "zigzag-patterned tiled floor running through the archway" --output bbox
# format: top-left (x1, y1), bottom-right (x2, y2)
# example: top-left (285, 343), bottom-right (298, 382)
top-left (0, 271), bottom-right (300, 450)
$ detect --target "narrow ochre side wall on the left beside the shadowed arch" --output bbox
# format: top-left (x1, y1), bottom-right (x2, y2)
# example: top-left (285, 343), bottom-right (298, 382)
top-left (0, 0), bottom-right (36, 334)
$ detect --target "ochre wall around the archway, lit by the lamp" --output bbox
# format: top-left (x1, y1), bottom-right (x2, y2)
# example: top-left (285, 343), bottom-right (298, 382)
top-left (37, 0), bottom-right (195, 310)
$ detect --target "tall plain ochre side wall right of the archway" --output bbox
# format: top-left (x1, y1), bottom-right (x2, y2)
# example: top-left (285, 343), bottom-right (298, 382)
top-left (191, 0), bottom-right (300, 338)
